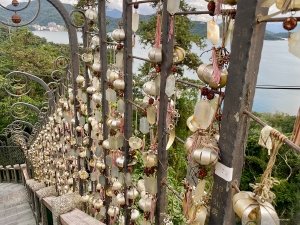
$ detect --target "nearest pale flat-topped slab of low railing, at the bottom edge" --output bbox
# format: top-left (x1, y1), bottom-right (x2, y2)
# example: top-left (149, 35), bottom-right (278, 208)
top-left (60, 208), bottom-right (104, 225)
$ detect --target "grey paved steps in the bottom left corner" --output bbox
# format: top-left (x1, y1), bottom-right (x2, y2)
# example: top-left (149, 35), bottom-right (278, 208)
top-left (0, 183), bottom-right (36, 225)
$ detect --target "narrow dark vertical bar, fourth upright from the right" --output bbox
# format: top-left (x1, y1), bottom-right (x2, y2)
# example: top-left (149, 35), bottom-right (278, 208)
top-left (98, 0), bottom-right (110, 221)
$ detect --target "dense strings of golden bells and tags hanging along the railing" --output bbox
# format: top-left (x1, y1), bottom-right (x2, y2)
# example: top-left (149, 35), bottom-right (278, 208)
top-left (21, 0), bottom-right (299, 225)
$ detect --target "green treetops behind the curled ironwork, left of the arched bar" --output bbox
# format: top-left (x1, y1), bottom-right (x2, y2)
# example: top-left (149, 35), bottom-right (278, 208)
top-left (0, 27), bottom-right (65, 132)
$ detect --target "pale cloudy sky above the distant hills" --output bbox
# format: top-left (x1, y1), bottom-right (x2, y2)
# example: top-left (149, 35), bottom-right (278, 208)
top-left (0, 0), bottom-right (286, 21)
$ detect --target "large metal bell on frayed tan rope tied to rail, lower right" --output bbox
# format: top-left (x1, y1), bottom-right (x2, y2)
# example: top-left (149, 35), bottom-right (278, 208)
top-left (233, 126), bottom-right (287, 225)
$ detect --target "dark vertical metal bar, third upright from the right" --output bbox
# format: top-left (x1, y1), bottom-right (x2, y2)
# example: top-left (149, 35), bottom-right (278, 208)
top-left (123, 0), bottom-right (132, 224)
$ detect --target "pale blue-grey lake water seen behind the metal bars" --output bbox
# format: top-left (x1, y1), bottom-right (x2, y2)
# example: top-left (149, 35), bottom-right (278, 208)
top-left (33, 31), bottom-right (300, 115)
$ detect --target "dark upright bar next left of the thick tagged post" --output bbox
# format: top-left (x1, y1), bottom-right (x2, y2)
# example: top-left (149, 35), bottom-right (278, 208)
top-left (155, 1), bottom-right (174, 225)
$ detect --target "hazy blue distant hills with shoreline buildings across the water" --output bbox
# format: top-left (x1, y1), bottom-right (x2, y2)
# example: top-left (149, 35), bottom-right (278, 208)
top-left (0, 0), bottom-right (289, 40)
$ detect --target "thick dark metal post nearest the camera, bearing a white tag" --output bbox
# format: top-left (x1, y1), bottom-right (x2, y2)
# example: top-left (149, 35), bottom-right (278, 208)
top-left (209, 0), bottom-right (268, 225)
